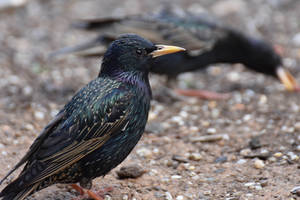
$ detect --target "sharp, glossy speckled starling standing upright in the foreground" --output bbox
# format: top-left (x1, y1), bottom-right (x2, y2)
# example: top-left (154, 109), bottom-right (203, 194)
top-left (0, 34), bottom-right (184, 200)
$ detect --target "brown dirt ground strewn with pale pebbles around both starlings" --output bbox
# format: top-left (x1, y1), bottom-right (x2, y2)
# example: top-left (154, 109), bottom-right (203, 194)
top-left (0, 0), bottom-right (300, 200)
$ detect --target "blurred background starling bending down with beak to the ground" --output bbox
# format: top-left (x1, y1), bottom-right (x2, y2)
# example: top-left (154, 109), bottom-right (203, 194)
top-left (51, 7), bottom-right (297, 94)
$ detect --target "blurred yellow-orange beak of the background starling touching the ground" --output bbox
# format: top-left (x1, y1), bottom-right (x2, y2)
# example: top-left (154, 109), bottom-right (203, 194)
top-left (276, 67), bottom-right (299, 91)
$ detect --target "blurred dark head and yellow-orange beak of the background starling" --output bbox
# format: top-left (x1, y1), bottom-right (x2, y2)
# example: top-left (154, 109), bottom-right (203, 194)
top-left (239, 38), bottom-right (299, 91)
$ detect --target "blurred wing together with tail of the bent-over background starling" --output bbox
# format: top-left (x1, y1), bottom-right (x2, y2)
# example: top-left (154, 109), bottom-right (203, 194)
top-left (50, 9), bottom-right (228, 57)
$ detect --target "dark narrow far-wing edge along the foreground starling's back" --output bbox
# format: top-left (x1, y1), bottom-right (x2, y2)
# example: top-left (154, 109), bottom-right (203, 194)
top-left (0, 112), bottom-right (65, 185)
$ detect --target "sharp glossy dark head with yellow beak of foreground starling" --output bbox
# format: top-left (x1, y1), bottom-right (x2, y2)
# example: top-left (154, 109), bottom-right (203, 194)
top-left (100, 34), bottom-right (184, 75)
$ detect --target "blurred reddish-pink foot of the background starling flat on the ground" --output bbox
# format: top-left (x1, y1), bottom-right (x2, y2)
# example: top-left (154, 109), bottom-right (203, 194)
top-left (175, 89), bottom-right (230, 100)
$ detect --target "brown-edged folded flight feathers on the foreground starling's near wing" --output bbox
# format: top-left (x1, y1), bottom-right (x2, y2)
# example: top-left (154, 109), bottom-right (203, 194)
top-left (24, 92), bottom-right (130, 184)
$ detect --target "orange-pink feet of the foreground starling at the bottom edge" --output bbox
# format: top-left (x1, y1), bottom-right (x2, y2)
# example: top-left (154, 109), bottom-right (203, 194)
top-left (71, 184), bottom-right (113, 200)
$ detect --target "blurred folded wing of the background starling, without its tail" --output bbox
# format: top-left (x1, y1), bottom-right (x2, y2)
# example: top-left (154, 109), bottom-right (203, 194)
top-left (74, 10), bottom-right (227, 51)
